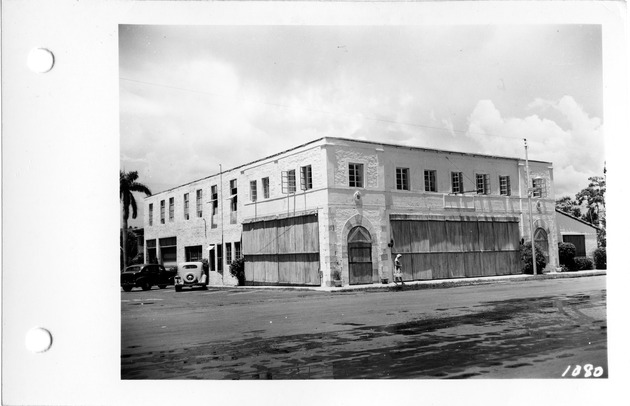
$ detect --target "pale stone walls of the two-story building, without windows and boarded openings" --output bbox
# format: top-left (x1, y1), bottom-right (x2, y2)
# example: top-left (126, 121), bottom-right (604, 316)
top-left (144, 137), bottom-right (558, 286)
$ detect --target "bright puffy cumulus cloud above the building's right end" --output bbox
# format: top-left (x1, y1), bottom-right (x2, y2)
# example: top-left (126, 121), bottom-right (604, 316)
top-left (466, 96), bottom-right (605, 197)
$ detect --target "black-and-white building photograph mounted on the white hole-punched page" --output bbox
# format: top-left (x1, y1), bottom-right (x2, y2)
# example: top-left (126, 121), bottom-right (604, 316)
top-left (119, 24), bottom-right (608, 380)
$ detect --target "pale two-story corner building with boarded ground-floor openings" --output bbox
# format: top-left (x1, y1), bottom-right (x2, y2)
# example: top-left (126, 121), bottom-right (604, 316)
top-left (144, 137), bottom-right (558, 286)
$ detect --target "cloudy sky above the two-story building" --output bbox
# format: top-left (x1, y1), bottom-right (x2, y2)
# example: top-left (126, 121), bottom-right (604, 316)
top-left (119, 25), bottom-right (605, 226)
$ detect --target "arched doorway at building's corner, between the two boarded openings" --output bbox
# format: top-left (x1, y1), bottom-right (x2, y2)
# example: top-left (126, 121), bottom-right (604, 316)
top-left (348, 226), bottom-right (372, 285)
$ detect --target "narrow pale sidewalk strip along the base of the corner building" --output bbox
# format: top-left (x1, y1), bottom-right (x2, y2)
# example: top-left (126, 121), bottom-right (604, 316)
top-left (211, 270), bottom-right (606, 293)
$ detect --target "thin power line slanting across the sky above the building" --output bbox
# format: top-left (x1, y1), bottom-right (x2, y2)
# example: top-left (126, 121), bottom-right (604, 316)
top-left (120, 77), bottom-right (520, 140)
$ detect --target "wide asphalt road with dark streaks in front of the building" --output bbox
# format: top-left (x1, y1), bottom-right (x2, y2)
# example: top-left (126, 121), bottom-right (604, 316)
top-left (121, 276), bottom-right (608, 379)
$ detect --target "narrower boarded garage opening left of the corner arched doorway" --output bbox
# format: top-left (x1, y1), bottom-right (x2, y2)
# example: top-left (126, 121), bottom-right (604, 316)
top-left (243, 214), bottom-right (321, 286)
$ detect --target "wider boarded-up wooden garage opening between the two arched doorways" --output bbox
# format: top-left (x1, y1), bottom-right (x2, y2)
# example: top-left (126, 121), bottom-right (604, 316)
top-left (390, 215), bottom-right (521, 280)
